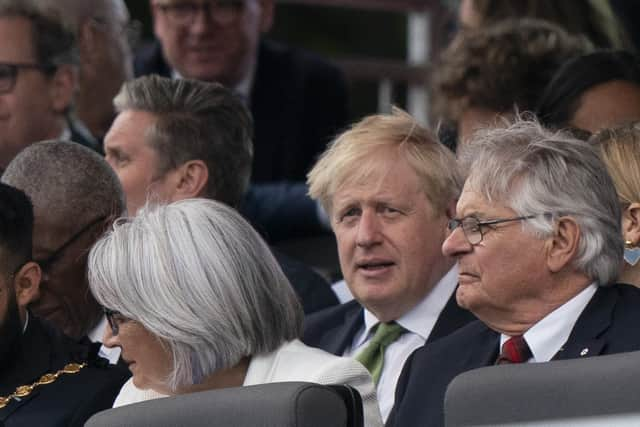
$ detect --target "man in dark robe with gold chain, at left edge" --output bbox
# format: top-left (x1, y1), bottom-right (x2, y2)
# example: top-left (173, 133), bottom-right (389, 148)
top-left (0, 184), bottom-right (129, 427)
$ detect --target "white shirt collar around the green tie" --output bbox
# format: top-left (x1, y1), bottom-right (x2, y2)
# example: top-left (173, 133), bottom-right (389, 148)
top-left (353, 263), bottom-right (458, 348)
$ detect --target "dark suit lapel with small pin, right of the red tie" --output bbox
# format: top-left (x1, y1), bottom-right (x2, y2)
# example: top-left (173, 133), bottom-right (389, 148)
top-left (553, 286), bottom-right (618, 360)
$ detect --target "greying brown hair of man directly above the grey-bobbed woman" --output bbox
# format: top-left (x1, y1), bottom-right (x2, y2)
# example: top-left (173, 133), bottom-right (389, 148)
top-left (114, 75), bottom-right (253, 207)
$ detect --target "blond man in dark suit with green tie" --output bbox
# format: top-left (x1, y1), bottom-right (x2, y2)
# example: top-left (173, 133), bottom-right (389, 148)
top-left (303, 109), bottom-right (473, 419)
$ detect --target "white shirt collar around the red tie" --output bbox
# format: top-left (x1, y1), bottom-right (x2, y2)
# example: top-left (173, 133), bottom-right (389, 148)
top-left (500, 282), bottom-right (598, 362)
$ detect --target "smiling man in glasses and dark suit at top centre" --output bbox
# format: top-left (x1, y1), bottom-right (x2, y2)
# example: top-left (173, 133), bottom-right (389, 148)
top-left (135, 0), bottom-right (348, 182)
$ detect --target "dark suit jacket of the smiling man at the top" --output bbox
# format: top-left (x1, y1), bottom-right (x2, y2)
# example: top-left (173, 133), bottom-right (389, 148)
top-left (134, 41), bottom-right (348, 182)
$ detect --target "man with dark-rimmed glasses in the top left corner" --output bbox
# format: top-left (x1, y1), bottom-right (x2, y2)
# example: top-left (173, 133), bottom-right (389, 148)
top-left (0, 0), bottom-right (99, 170)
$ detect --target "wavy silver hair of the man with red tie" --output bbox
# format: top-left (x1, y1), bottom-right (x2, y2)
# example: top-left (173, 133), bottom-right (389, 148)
top-left (460, 119), bottom-right (624, 285)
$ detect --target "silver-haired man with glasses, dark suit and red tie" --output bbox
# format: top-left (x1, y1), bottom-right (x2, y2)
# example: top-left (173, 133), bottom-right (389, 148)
top-left (389, 121), bottom-right (640, 427)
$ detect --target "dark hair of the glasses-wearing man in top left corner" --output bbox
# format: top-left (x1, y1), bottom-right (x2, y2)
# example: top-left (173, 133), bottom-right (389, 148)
top-left (0, 0), bottom-right (79, 67)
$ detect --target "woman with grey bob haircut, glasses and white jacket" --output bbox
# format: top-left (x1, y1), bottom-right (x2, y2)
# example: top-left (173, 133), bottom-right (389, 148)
top-left (88, 199), bottom-right (381, 425)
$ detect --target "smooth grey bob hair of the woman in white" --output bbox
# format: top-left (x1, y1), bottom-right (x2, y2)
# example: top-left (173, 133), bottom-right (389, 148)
top-left (88, 199), bottom-right (303, 390)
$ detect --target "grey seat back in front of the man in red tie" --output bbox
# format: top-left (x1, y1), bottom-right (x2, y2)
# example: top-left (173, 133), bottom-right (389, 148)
top-left (444, 352), bottom-right (640, 427)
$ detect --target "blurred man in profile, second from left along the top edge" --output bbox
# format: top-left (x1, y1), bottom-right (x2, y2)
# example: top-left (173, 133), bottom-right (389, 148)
top-left (38, 0), bottom-right (139, 140)
